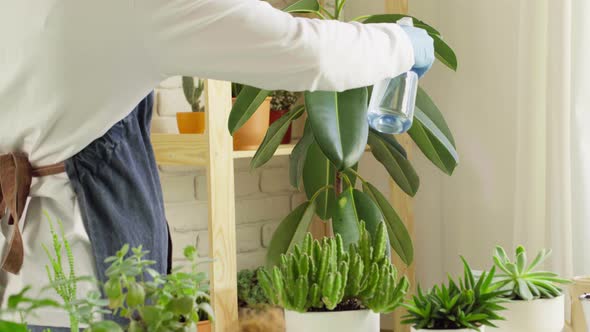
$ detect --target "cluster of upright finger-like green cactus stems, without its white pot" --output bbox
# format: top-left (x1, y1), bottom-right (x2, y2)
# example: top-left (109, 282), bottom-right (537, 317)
top-left (258, 222), bottom-right (409, 313)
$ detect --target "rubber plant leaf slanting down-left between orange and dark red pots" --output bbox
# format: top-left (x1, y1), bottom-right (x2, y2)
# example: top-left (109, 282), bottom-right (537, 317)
top-left (250, 105), bottom-right (305, 169)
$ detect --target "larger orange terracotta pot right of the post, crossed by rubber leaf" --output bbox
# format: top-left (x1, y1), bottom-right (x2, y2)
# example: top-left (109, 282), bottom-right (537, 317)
top-left (234, 98), bottom-right (271, 151)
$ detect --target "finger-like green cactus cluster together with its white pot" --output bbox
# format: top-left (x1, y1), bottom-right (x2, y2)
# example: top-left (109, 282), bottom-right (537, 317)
top-left (258, 223), bottom-right (409, 332)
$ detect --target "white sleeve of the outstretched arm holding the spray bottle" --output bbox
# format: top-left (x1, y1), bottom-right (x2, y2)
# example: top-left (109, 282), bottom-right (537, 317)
top-left (135, 0), bottom-right (414, 91)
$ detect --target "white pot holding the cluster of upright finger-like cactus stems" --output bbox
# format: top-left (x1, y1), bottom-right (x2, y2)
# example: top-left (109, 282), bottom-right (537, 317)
top-left (285, 310), bottom-right (380, 332)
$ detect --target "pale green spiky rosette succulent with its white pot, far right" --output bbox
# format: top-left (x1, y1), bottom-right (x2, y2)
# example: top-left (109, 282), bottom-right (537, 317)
top-left (491, 246), bottom-right (570, 332)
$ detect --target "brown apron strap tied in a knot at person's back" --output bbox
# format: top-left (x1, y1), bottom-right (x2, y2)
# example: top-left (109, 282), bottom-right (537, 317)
top-left (0, 153), bottom-right (65, 274)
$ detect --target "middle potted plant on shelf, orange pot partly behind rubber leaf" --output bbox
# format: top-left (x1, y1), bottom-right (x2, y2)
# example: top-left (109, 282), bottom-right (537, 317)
top-left (230, 83), bottom-right (272, 151)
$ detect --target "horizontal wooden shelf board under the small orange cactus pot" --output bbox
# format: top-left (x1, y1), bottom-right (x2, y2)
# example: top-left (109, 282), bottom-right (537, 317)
top-left (152, 134), bottom-right (209, 166)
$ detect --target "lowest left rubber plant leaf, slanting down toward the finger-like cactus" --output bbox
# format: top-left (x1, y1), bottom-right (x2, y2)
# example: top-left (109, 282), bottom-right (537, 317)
top-left (266, 201), bottom-right (316, 266)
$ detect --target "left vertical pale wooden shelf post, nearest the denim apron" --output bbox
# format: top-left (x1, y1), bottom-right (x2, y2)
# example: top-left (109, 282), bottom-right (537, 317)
top-left (205, 80), bottom-right (238, 332)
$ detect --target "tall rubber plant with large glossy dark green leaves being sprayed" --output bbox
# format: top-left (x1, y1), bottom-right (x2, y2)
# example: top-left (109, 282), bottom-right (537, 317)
top-left (228, 0), bottom-right (458, 265)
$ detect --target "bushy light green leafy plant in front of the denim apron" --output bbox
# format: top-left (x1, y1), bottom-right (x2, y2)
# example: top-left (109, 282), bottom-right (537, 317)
top-left (104, 245), bottom-right (213, 331)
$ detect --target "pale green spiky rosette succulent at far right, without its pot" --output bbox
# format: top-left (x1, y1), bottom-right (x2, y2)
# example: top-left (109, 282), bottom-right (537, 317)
top-left (494, 246), bottom-right (570, 301)
